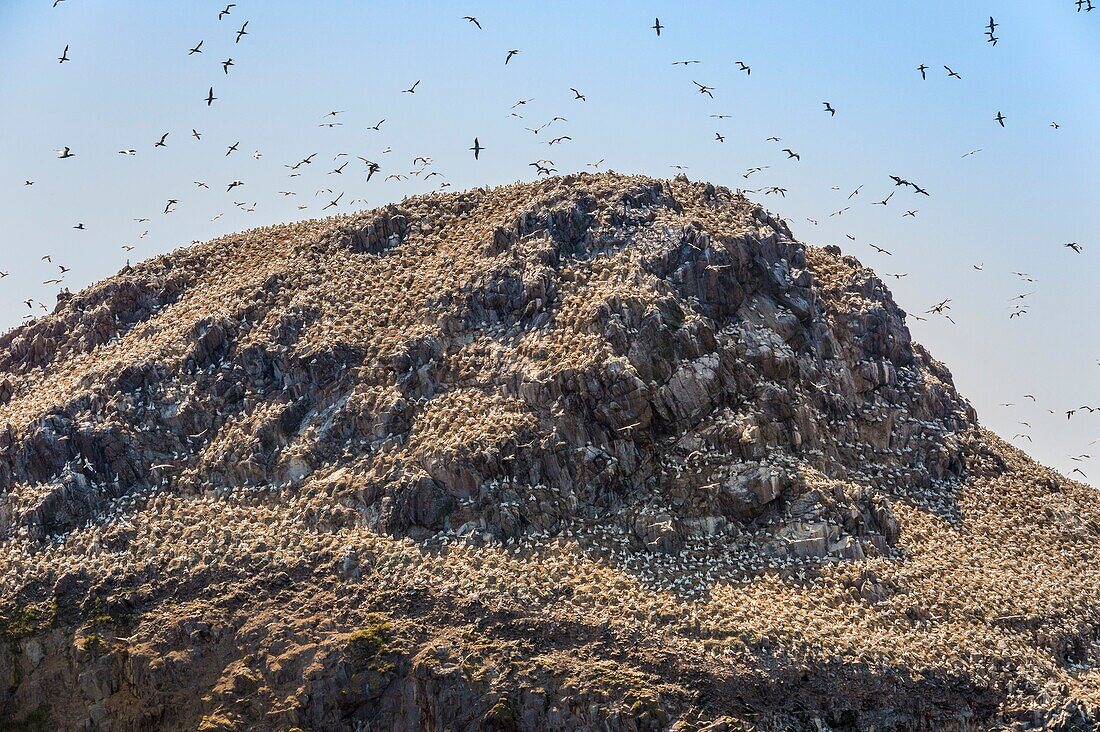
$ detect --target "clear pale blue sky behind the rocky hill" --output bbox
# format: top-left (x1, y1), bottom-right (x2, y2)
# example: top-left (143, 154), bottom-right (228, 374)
top-left (0, 0), bottom-right (1100, 485)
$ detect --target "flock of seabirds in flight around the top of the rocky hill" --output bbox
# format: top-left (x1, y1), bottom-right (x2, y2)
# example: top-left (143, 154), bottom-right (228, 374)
top-left (0, 0), bottom-right (1093, 476)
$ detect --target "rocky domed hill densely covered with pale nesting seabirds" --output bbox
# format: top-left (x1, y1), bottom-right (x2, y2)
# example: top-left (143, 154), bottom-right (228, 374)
top-left (0, 174), bottom-right (1100, 730)
